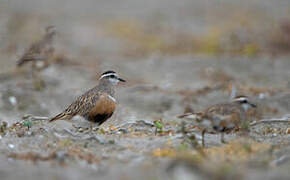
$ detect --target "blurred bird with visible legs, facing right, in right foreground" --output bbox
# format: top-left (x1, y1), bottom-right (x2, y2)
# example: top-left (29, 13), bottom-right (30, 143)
top-left (178, 95), bottom-right (257, 146)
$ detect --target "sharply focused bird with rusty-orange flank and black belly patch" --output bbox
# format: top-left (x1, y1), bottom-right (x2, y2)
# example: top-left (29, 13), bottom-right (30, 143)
top-left (49, 71), bottom-right (126, 125)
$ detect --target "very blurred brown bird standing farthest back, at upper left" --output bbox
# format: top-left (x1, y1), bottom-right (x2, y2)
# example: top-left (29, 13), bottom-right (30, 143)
top-left (17, 26), bottom-right (56, 69)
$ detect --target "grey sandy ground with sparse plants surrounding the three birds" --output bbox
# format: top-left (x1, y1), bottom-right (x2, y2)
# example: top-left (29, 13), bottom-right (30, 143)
top-left (0, 0), bottom-right (290, 180)
